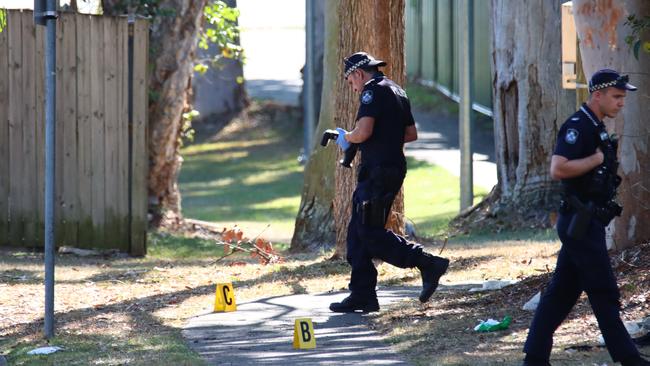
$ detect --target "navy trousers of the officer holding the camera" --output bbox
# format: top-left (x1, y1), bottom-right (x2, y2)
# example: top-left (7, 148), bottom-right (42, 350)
top-left (347, 170), bottom-right (422, 297)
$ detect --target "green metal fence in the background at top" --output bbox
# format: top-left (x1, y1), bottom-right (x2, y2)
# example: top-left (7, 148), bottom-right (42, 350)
top-left (406, 0), bottom-right (492, 116)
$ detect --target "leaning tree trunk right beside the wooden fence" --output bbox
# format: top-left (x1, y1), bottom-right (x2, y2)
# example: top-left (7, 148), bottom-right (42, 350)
top-left (148, 0), bottom-right (207, 219)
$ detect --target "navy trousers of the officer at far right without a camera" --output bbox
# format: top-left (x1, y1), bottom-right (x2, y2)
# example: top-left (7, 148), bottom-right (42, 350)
top-left (524, 213), bottom-right (639, 362)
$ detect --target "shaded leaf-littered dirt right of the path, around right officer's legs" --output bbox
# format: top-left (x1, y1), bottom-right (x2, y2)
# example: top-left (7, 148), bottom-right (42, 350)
top-left (373, 244), bottom-right (650, 365)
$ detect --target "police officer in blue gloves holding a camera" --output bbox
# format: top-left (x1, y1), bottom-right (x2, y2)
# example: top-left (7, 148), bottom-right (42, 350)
top-left (330, 52), bottom-right (449, 313)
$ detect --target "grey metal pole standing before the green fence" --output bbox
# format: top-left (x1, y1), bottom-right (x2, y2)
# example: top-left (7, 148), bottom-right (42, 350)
top-left (458, 0), bottom-right (474, 211)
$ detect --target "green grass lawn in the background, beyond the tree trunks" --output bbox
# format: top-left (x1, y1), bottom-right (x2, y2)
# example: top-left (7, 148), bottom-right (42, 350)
top-left (179, 100), bottom-right (486, 244)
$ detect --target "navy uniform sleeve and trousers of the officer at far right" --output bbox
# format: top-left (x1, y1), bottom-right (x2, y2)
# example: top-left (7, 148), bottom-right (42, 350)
top-left (524, 69), bottom-right (639, 365)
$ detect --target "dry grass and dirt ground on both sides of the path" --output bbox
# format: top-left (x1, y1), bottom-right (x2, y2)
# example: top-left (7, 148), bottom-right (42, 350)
top-left (0, 224), bottom-right (650, 365)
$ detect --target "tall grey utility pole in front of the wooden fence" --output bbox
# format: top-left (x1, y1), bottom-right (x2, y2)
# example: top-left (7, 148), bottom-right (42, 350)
top-left (34, 0), bottom-right (57, 339)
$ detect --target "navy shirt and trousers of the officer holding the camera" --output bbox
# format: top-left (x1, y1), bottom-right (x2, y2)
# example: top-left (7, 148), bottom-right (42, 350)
top-left (347, 73), bottom-right (422, 298)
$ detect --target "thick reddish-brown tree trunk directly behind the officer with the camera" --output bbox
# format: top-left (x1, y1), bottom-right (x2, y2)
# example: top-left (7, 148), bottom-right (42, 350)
top-left (292, 0), bottom-right (406, 257)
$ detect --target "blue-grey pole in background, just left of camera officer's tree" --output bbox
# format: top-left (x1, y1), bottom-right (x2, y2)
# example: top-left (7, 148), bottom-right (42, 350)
top-left (302, 0), bottom-right (316, 162)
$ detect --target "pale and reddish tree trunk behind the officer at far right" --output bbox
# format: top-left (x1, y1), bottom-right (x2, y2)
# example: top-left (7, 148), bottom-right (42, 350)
top-left (573, 0), bottom-right (650, 250)
